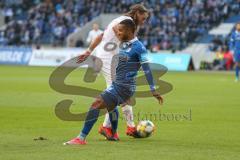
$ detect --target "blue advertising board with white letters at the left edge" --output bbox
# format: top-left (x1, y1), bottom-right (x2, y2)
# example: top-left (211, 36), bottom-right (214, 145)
top-left (0, 47), bottom-right (32, 65)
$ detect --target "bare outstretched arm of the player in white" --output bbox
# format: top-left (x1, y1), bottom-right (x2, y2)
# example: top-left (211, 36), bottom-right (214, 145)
top-left (77, 33), bottom-right (103, 63)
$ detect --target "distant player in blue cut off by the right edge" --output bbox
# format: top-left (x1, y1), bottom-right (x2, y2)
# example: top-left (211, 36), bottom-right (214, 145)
top-left (229, 22), bottom-right (240, 82)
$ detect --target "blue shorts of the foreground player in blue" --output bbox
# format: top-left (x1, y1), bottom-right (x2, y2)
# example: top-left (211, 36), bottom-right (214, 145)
top-left (101, 82), bottom-right (135, 109)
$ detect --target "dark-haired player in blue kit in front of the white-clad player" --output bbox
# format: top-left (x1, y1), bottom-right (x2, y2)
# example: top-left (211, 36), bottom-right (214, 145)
top-left (64, 19), bottom-right (163, 145)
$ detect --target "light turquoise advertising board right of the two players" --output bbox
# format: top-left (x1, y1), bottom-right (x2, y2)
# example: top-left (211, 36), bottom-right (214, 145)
top-left (148, 53), bottom-right (191, 71)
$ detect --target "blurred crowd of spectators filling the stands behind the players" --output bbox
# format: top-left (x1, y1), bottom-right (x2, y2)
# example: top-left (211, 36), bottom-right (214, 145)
top-left (0, 0), bottom-right (240, 51)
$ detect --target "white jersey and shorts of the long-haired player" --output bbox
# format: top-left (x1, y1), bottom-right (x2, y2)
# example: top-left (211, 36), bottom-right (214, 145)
top-left (95, 16), bottom-right (132, 86)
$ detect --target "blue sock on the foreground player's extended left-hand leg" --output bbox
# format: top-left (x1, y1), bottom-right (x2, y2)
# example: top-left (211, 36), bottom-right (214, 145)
top-left (79, 107), bottom-right (100, 139)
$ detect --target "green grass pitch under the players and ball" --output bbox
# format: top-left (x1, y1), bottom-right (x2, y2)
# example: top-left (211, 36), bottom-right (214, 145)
top-left (0, 66), bottom-right (240, 160)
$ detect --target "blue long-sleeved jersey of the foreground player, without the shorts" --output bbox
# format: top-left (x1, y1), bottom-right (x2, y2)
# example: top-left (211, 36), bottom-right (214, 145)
top-left (114, 38), bottom-right (154, 89)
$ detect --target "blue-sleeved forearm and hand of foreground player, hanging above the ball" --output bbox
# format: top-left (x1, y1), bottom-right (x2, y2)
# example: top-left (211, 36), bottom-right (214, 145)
top-left (142, 62), bottom-right (163, 104)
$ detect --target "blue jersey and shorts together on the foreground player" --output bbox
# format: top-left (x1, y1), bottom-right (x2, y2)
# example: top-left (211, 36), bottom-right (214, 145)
top-left (101, 38), bottom-right (155, 108)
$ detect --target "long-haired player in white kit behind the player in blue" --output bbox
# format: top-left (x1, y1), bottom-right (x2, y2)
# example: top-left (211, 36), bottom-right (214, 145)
top-left (78, 4), bottom-right (149, 137)
